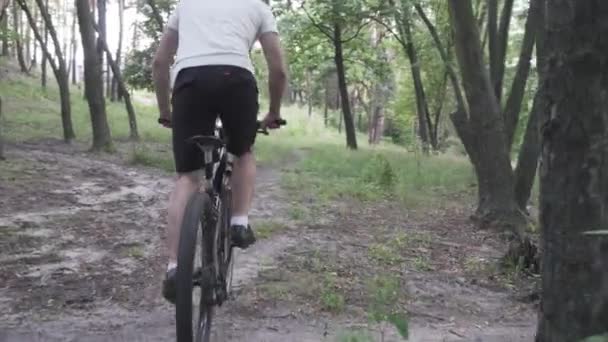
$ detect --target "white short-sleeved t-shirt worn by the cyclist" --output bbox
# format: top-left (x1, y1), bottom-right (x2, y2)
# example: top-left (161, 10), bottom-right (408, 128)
top-left (167, 0), bottom-right (278, 84)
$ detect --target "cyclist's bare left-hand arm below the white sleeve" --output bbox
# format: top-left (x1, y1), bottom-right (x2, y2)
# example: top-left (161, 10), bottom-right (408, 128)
top-left (152, 28), bottom-right (178, 121)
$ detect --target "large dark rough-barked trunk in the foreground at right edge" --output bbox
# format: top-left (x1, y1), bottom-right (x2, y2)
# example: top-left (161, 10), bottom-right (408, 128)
top-left (536, 0), bottom-right (608, 342)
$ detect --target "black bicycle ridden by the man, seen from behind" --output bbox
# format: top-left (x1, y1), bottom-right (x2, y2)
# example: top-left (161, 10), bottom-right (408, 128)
top-left (175, 120), bottom-right (287, 342)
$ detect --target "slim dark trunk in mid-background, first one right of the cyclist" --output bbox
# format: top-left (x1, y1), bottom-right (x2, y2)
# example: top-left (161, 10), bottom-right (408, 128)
top-left (333, 22), bottom-right (357, 150)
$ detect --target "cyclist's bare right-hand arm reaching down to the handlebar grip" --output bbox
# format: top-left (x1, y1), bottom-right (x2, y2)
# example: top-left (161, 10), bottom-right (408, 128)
top-left (260, 32), bottom-right (287, 118)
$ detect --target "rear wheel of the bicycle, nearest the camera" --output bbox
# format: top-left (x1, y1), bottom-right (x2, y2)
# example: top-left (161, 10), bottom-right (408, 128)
top-left (175, 192), bottom-right (215, 342)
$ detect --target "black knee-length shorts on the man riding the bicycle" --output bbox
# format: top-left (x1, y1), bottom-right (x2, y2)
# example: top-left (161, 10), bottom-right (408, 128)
top-left (172, 65), bottom-right (259, 173)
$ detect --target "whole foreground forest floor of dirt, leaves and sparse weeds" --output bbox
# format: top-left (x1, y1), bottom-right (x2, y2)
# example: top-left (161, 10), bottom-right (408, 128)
top-left (0, 141), bottom-right (536, 341)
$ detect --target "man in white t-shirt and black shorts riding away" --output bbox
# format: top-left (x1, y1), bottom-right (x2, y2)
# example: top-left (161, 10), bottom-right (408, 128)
top-left (153, 0), bottom-right (287, 303)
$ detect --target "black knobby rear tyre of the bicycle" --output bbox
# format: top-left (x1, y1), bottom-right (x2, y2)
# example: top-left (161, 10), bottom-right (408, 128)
top-left (175, 192), bottom-right (213, 342)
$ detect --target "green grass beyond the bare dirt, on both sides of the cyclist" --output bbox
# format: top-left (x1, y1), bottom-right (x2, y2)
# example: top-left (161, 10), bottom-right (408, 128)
top-left (0, 58), bottom-right (474, 208)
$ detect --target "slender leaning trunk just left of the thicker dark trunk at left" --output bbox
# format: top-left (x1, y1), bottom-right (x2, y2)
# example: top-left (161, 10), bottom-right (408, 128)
top-left (31, 0), bottom-right (75, 142)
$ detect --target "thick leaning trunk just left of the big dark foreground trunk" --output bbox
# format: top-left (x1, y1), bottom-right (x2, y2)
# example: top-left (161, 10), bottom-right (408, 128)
top-left (448, 0), bottom-right (524, 237)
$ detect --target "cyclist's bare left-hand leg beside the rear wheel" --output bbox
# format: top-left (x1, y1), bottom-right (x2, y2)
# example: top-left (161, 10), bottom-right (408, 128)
top-left (167, 171), bottom-right (199, 268)
